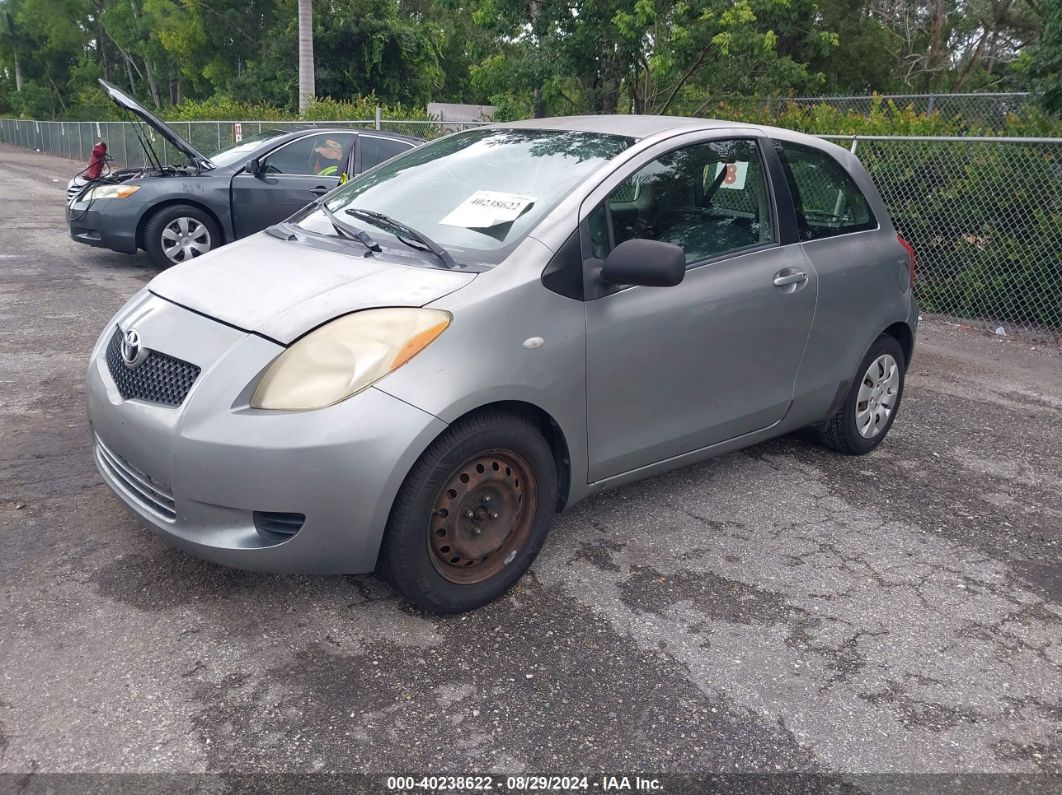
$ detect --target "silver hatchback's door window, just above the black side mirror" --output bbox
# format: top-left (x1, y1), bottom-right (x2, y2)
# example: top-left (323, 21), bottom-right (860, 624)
top-left (589, 139), bottom-right (774, 264)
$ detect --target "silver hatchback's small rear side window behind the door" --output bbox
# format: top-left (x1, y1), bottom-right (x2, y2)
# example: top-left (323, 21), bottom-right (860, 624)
top-left (776, 141), bottom-right (877, 240)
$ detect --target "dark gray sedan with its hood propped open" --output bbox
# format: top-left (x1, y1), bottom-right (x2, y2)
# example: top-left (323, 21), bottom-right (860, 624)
top-left (67, 81), bottom-right (421, 267)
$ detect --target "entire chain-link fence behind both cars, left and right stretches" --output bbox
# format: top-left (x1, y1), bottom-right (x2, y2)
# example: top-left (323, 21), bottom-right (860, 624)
top-left (0, 114), bottom-right (1062, 338)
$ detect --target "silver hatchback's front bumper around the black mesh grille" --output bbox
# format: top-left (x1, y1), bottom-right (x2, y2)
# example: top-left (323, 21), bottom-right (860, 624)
top-left (87, 292), bottom-right (446, 573)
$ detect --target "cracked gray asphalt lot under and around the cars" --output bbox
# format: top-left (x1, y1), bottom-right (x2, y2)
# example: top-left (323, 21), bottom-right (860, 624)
top-left (0, 145), bottom-right (1062, 775)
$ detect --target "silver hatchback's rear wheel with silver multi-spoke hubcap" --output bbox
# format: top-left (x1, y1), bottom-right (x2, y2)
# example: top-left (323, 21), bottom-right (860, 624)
top-left (819, 334), bottom-right (906, 455)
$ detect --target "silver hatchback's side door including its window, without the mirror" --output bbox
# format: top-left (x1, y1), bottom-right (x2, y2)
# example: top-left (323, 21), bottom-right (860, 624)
top-left (581, 134), bottom-right (817, 482)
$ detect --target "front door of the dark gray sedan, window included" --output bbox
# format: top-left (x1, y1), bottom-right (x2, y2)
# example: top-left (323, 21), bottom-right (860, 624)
top-left (232, 131), bottom-right (357, 238)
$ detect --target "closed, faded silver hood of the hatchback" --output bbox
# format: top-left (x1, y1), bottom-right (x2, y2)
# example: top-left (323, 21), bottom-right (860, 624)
top-left (148, 232), bottom-right (476, 345)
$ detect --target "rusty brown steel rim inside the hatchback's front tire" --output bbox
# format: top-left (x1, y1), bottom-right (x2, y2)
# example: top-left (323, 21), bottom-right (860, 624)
top-left (427, 450), bottom-right (537, 585)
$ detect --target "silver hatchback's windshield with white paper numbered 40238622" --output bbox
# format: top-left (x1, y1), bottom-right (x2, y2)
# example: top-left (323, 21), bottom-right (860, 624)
top-left (292, 128), bottom-right (634, 264)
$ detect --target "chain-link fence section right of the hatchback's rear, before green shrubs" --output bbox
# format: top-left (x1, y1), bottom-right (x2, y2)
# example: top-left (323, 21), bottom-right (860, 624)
top-left (824, 136), bottom-right (1062, 338)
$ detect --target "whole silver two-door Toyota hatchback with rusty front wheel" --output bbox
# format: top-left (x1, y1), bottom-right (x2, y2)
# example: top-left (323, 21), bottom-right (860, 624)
top-left (87, 116), bottom-right (918, 612)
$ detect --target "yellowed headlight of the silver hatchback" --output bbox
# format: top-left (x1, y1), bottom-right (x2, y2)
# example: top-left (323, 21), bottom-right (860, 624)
top-left (251, 309), bottom-right (450, 411)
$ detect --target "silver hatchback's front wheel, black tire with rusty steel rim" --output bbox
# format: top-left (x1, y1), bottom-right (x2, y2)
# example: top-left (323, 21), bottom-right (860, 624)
top-left (380, 411), bottom-right (558, 613)
